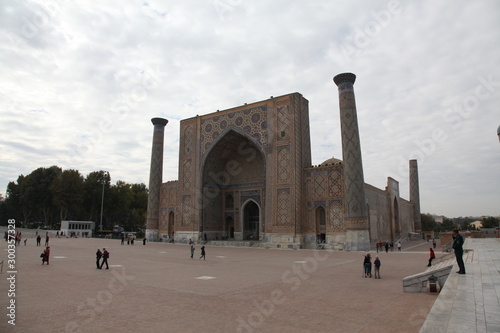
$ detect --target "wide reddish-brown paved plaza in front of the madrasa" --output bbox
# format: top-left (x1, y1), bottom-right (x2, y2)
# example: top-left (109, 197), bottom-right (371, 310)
top-left (0, 230), bottom-right (496, 332)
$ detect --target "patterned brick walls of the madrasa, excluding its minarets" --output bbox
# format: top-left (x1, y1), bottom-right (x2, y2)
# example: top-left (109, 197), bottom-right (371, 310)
top-left (159, 93), bottom-right (414, 249)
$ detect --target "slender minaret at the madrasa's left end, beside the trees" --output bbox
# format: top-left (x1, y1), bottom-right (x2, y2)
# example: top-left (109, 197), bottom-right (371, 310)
top-left (146, 118), bottom-right (168, 241)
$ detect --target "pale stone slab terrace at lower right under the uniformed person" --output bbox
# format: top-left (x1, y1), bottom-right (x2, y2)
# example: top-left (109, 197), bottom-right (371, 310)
top-left (420, 238), bottom-right (500, 333)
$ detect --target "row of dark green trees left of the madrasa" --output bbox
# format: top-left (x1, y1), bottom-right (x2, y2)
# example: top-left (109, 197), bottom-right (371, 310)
top-left (0, 166), bottom-right (148, 231)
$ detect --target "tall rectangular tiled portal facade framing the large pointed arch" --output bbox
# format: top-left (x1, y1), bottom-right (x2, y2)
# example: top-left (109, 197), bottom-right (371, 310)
top-left (171, 93), bottom-right (311, 243)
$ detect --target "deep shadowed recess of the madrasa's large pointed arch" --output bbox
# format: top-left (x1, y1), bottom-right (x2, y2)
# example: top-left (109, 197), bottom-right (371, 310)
top-left (200, 130), bottom-right (265, 240)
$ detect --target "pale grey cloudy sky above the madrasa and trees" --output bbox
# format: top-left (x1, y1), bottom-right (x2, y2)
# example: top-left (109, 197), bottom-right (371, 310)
top-left (0, 0), bottom-right (500, 217)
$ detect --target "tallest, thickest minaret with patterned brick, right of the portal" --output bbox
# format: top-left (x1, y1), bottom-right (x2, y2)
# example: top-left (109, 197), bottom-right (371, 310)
top-left (333, 73), bottom-right (370, 251)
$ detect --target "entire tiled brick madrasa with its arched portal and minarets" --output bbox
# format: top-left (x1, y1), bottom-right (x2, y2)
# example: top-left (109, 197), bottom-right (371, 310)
top-left (146, 73), bottom-right (421, 251)
